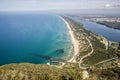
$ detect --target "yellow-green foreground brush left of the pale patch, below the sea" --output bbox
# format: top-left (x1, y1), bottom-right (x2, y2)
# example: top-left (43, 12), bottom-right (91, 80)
top-left (0, 63), bottom-right (82, 80)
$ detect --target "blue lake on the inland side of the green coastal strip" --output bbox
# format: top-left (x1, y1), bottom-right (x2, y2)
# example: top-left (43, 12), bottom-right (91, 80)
top-left (74, 18), bottom-right (120, 42)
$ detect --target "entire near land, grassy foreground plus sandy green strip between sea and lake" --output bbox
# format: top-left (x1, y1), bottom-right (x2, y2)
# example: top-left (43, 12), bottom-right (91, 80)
top-left (0, 16), bottom-right (120, 80)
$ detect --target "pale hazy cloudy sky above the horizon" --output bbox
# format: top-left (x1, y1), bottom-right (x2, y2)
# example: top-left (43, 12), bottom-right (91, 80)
top-left (0, 0), bottom-right (120, 12)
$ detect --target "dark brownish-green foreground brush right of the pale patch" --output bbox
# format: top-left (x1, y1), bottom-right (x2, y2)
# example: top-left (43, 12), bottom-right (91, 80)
top-left (88, 67), bottom-right (120, 80)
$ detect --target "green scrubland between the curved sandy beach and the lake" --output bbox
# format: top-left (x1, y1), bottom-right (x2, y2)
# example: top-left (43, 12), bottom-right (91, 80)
top-left (63, 18), bottom-right (115, 65)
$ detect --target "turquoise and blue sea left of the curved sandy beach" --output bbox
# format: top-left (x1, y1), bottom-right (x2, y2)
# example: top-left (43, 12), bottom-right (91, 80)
top-left (0, 14), bottom-right (72, 65)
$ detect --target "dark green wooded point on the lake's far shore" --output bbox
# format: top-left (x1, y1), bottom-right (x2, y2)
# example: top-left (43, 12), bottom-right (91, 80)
top-left (97, 21), bottom-right (120, 29)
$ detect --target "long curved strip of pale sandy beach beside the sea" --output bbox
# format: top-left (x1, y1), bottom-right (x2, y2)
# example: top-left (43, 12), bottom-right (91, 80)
top-left (59, 16), bottom-right (79, 63)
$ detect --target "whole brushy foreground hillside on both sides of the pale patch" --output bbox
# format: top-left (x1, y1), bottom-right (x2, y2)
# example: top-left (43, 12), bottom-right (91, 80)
top-left (0, 63), bottom-right (120, 80)
